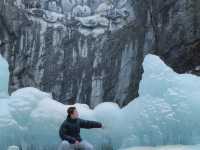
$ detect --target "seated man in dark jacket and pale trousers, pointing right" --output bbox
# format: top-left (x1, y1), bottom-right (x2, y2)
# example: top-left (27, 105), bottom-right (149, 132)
top-left (59, 107), bottom-right (102, 150)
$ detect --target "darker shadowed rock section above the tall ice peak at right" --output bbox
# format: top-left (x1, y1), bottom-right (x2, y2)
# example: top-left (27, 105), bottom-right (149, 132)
top-left (141, 0), bottom-right (200, 75)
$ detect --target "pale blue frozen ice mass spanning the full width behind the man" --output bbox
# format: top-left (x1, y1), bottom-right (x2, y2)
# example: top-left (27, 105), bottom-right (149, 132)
top-left (0, 55), bottom-right (200, 150)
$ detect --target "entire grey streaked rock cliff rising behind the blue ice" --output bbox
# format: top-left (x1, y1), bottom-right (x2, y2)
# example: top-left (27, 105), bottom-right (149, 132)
top-left (0, 0), bottom-right (200, 107)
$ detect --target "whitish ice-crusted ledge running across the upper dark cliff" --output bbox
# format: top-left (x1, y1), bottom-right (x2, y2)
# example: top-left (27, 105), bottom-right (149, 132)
top-left (24, 8), bottom-right (131, 37)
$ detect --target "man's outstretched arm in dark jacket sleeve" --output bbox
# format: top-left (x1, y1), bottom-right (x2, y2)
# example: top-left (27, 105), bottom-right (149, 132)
top-left (79, 119), bottom-right (102, 129)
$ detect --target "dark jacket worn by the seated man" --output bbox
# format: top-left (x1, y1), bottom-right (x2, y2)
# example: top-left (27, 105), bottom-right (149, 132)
top-left (59, 117), bottom-right (102, 144)
